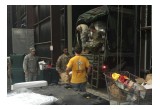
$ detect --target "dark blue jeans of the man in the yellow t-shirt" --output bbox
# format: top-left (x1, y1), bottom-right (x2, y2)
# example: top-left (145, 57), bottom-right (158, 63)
top-left (71, 82), bottom-right (87, 92)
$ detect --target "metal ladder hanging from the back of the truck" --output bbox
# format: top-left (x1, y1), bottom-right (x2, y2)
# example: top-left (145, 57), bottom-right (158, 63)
top-left (91, 54), bottom-right (104, 88)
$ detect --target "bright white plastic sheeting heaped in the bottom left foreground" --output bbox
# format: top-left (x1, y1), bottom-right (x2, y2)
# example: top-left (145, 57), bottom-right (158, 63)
top-left (7, 88), bottom-right (58, 105)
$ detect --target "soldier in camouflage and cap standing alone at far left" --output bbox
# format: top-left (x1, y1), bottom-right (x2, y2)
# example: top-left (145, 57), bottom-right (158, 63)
top-left (23, 47), bottom-right (38, 82)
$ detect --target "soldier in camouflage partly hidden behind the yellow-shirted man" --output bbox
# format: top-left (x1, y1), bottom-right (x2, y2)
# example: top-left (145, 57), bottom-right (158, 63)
top-left (56, 48), bottom-right (71, 83)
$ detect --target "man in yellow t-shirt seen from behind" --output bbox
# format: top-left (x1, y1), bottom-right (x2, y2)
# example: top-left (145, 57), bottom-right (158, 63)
top-left (66, 47), bottom-right (90, 92)
